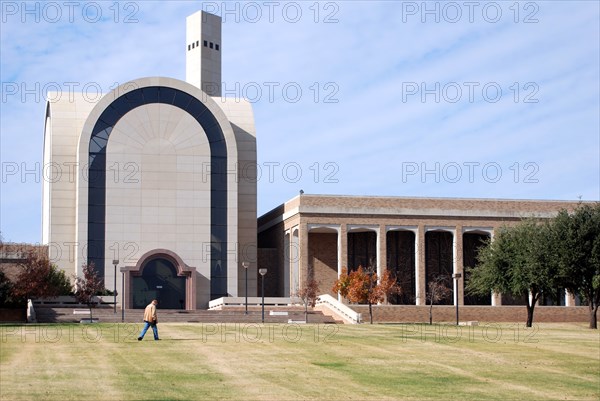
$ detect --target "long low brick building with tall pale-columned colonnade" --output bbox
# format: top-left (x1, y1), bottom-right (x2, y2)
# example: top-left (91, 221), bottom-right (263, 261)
top-left (258, 194), bottom-right (577, 306)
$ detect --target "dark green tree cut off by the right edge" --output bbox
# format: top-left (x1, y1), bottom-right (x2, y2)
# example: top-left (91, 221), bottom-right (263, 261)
top-left (553, 203), bottom-right (600, 329)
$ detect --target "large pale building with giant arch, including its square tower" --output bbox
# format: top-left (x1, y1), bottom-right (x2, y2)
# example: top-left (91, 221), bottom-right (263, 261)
top-left (42, 11), bottom-right (257, 309)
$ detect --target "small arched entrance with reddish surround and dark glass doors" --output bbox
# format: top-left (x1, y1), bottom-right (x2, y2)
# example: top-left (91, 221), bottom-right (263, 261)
top-left (125, 249), bottom-right (196, 310)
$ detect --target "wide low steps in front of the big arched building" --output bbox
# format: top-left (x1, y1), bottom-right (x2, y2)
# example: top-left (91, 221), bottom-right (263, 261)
top-left (35, 306), bottom-right (341, 324)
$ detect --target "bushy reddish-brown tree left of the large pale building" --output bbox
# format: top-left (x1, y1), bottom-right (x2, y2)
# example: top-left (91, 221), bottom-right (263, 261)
top-left (13, 251), bottom-right (72, 301)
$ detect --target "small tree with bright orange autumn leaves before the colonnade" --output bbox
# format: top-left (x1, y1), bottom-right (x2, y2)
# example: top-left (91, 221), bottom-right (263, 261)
top-left (333, 263), bottom-right (401, 324)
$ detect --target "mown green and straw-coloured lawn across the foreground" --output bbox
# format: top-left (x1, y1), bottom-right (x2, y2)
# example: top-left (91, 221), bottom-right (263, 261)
top-left (0, 323), bottom-right (600, 401)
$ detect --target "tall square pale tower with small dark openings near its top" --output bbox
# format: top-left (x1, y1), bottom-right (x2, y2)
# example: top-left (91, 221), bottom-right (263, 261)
top-left (185, 11), bottom-right (222, 97)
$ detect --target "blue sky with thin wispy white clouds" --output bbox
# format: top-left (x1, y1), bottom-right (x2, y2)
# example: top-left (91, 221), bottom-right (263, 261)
top-left (0, 1), bottom-right (600, 243)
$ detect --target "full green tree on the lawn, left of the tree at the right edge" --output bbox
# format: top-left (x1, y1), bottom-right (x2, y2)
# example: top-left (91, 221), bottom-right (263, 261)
top-left (467, 219), bottom-right (558, 327)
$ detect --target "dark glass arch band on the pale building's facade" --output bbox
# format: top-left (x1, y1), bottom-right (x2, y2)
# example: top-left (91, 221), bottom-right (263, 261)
top-left (88, 86), bottom-right (227, 299)
